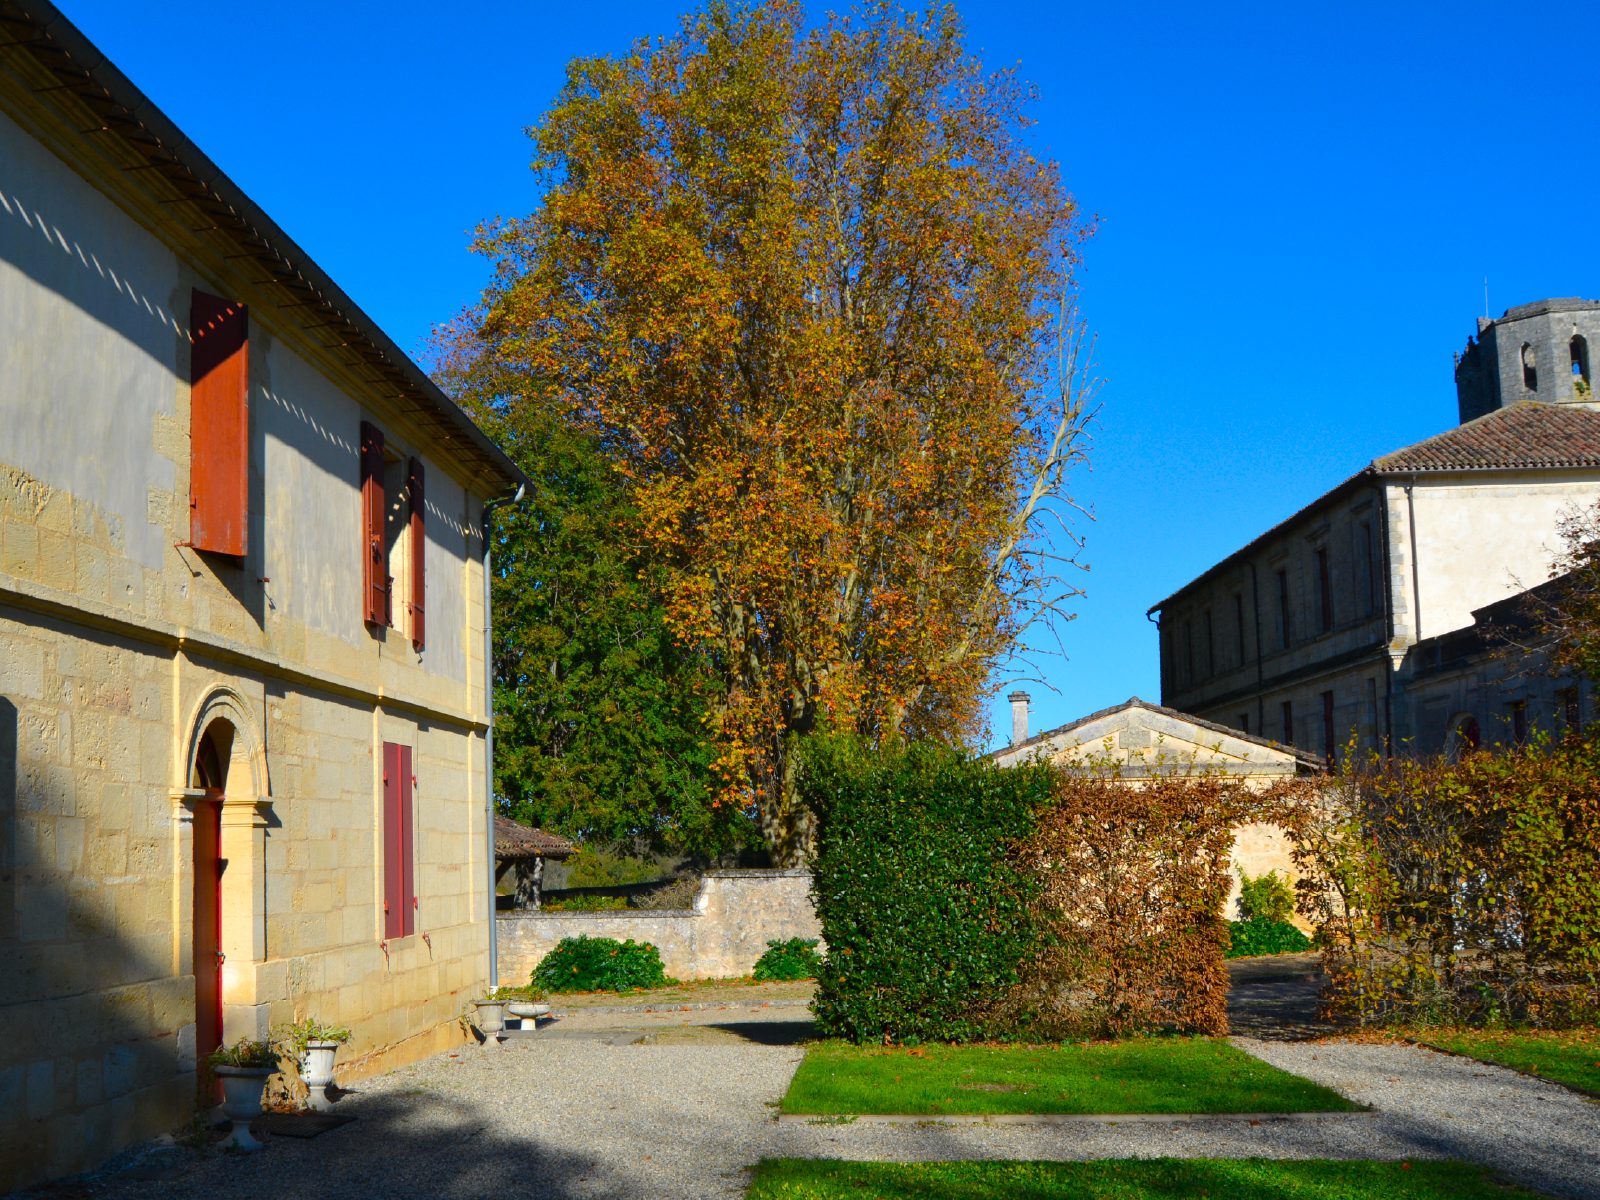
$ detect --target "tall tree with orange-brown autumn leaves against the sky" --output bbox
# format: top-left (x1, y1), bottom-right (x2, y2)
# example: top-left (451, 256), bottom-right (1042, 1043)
top-left (457, 0), bottom-right (1086, 862)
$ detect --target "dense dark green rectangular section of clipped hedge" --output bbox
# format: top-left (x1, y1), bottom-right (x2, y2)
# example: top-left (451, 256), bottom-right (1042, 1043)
top-left (800, 736), bottom-right (1051, 1042)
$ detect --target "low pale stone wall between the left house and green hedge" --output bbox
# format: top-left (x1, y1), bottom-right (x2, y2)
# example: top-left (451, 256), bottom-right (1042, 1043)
top-left (494, 870), bottom-right (821, 984)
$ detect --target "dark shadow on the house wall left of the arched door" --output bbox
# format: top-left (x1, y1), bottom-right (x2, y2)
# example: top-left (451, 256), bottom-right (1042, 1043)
top-left (0, 696), bottom-right (194, 1194)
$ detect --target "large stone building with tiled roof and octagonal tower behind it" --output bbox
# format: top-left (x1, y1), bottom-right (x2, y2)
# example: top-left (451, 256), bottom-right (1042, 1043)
top-left (1150, 301), bottom-right (1600, 758)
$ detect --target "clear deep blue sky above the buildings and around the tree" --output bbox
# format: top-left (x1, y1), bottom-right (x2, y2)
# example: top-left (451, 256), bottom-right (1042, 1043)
top-left (58, 0), bottom-right (1600, 752)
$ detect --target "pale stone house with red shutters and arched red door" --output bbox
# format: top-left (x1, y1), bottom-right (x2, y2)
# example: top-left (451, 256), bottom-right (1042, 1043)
top-left (0, 0), bottom-right (525, 1192)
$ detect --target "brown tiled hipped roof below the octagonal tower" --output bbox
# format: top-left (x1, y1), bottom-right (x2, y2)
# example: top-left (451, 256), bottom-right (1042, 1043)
top-left (1373, 403), bottom-right (1600, 475)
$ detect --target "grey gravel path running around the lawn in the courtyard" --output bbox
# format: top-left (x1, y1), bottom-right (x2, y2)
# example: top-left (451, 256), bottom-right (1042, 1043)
top-left (56, 1005), bottom-right (1600, 1200)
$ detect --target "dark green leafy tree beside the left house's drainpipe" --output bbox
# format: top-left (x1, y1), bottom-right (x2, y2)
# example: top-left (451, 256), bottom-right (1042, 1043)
top-left (440, 352), bottom-right (757, 861)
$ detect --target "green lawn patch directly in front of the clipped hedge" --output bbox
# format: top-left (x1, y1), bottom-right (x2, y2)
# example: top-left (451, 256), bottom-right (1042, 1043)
top-left (782, 1037), bottom-right (1358, 1115)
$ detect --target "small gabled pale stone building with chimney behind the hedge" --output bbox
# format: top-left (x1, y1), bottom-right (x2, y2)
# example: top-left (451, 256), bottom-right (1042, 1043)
top-left (989, 691), bottom-right (1326, 914)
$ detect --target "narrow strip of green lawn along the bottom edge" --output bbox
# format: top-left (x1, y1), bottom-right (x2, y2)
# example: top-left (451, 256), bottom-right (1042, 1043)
top-left (746, 1158), bottom-right (1536, 1200)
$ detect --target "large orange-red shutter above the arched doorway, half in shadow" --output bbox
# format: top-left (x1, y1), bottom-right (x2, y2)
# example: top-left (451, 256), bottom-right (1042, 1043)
top-left (189, 290), bottom-right (250, 557)
